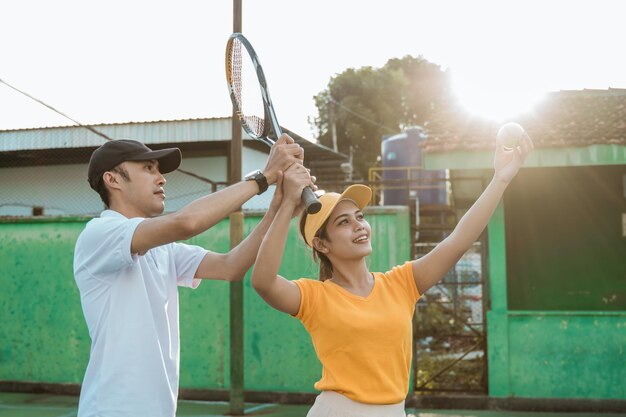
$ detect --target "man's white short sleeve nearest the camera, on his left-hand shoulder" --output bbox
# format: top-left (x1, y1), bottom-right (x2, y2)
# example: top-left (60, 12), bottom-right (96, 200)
top-left (75, 216), bottom-right (144, 277)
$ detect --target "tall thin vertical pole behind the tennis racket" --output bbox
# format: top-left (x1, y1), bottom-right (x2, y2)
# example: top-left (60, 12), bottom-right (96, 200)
top-left (229, 0), bottom-right (244, 415)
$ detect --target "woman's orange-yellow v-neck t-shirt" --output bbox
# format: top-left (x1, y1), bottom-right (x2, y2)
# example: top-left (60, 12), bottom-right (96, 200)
top-left (294, 262), bottom-right (420, 404)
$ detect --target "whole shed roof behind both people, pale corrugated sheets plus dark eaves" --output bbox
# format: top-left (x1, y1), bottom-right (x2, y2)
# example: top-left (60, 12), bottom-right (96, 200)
top-left (0, 117), bottom-right (348, 180)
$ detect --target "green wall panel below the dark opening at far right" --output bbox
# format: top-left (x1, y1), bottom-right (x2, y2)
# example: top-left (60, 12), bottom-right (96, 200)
top-left (487, 311), bottom-right (626, 400)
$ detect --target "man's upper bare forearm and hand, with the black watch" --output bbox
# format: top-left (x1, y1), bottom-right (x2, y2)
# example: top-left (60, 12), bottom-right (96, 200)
top-left (131, 135), bottom-right (304, 254)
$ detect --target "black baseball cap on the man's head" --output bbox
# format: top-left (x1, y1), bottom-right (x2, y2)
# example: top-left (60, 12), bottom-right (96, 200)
top-left (87, 139), bottom-right (182, 191)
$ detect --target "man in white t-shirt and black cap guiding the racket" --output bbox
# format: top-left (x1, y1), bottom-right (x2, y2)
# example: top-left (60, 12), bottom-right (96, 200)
top-left (74, 135), bottom-right (303, 417)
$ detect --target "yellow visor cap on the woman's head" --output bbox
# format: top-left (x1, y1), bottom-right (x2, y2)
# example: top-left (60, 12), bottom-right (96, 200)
top-left (304, 184), bottom-right (372, 246)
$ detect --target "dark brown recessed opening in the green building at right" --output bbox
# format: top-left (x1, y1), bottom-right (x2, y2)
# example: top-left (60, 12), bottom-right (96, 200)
top-left (504, 165), bottom-right (626, 311)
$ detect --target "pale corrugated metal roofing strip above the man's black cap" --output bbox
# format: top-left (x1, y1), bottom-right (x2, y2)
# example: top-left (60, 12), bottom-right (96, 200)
top-left (0, 117), bottom-right (234, 152)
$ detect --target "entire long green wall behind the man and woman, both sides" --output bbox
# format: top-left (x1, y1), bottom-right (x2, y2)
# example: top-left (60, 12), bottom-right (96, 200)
top-left (0, 208), bottom-right (410, 392)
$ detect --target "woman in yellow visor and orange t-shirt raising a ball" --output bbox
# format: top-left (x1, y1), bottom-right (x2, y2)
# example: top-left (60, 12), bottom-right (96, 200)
top-left (252, 136), bottom-right (533, 417)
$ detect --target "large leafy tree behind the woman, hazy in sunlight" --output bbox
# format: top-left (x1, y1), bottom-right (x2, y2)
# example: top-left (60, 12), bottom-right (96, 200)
top-left (312, 56), bottom-right (450, 178)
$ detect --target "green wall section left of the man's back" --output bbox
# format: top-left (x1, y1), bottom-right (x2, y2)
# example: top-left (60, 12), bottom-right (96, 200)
top-left (0, 221), bottom-right (89, 382)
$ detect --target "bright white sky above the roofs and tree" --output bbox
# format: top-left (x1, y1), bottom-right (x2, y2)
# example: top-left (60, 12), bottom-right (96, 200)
top-left (0, 0), bottom-right (626, 139)
